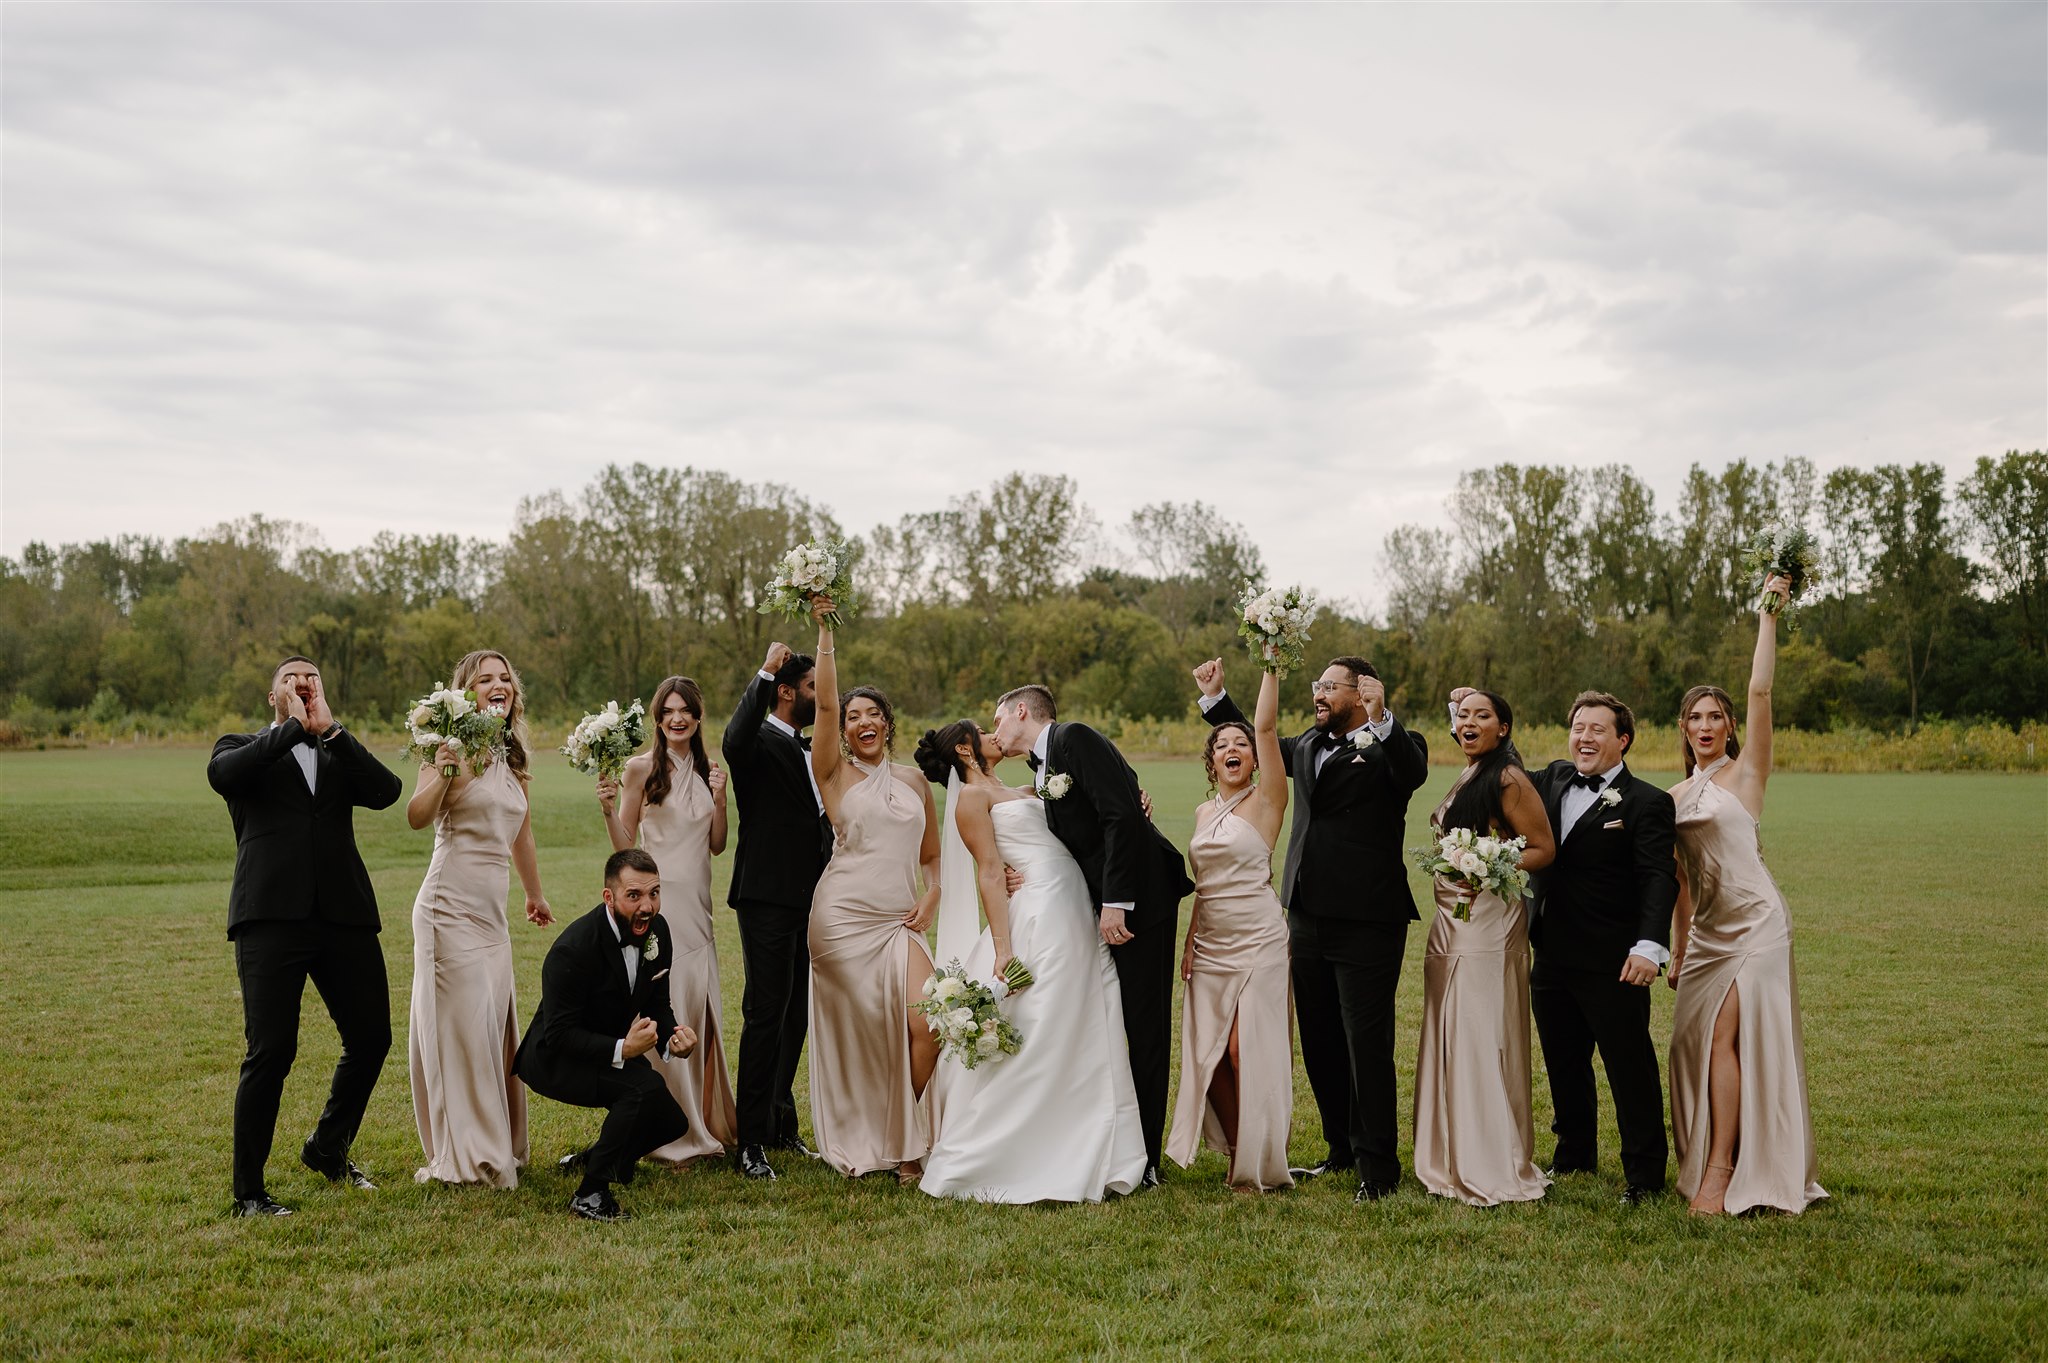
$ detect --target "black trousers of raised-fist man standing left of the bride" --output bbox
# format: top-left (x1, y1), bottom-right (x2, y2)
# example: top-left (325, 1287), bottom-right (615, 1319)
top-left (733, 900), bottom-right (811, 1146)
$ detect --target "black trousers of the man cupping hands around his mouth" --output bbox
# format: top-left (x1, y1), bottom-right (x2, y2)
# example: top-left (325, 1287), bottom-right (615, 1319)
top-left (233, 919), bottom-right (391, 1199)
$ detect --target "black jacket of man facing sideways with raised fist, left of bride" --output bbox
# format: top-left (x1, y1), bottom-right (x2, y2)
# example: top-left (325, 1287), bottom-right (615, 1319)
top-left (719, 675), bottom-right (831, 909)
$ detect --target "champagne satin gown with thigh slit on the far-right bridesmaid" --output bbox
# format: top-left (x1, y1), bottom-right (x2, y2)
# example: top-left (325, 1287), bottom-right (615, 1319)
top-left (1671, 757), bottom-right (1827, 1212)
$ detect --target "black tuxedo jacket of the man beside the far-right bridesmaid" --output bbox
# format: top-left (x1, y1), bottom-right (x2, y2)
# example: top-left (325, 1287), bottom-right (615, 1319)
top-left (1530, 761), bottom-right (1677, 972)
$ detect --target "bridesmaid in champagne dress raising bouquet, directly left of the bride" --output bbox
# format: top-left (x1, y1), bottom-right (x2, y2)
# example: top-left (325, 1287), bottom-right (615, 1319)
top-left (809, 598), bottom-right (938, 1183)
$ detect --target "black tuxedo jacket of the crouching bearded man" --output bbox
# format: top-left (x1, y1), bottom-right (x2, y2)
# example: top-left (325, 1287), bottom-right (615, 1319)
top-left (512, 905), bottom-right (676, 1105)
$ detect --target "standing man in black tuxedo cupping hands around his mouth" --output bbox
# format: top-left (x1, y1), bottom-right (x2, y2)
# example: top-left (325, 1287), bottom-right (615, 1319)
top-left (207, 655), bottom-right (403, 1216)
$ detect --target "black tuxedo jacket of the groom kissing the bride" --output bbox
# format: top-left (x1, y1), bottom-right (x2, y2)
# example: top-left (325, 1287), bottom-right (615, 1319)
top-left (1044, 722), bottom-right (1194, 933)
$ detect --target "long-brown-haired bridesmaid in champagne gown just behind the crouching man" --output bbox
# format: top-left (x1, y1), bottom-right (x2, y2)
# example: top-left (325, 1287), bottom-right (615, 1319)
top-left (598, 677), bottom-right (737, 1164)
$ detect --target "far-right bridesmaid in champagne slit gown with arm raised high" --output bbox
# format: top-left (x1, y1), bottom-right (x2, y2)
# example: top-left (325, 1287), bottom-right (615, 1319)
top-left (1669, 577), bottom-right (1827, 1214)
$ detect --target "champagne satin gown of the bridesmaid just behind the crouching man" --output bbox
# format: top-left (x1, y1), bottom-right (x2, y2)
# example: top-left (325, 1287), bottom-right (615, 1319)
top-left (641, 765), bottom-right (737, 1164)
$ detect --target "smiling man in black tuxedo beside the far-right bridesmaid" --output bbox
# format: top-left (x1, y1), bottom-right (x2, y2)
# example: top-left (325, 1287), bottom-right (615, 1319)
top-left (1490, 692), bottom-right (1677, 1203)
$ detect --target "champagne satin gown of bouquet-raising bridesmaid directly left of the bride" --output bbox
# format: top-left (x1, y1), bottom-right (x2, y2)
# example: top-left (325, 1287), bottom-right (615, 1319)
top-left (809, 763), bottom-right (932, 1177)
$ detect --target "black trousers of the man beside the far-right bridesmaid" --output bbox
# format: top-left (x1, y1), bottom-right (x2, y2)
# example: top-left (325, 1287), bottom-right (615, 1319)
top-left (1530, 950), bottom-right (1669, 1189)
